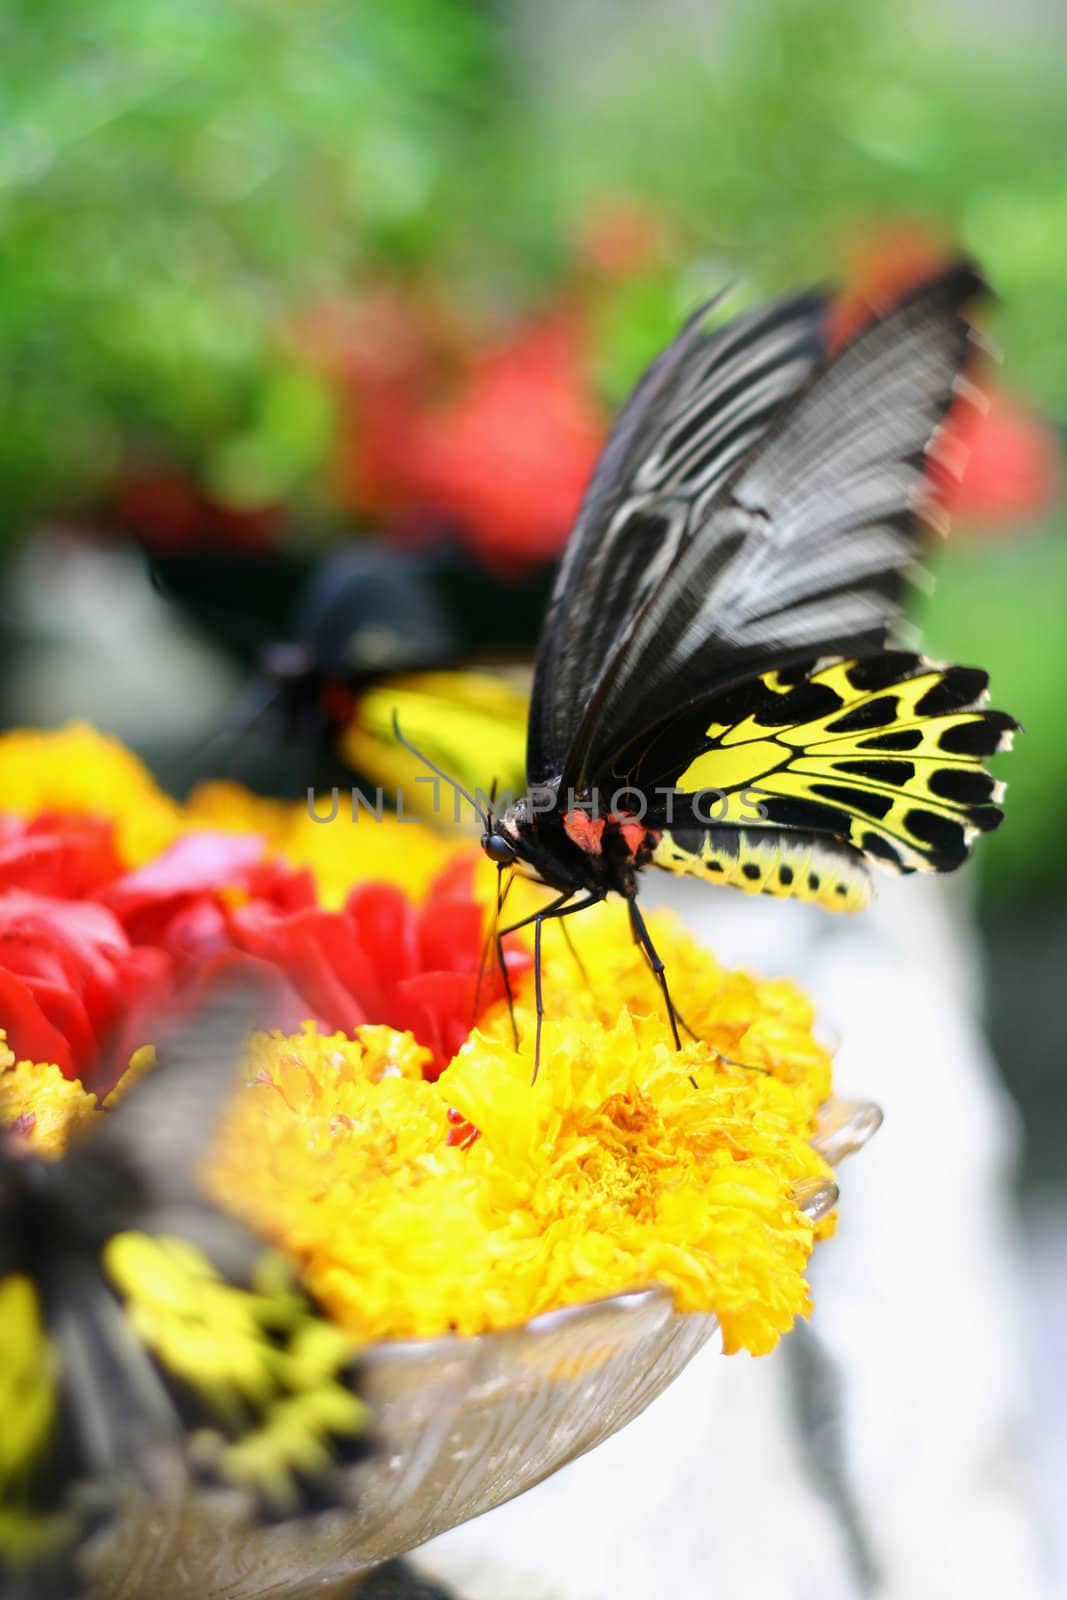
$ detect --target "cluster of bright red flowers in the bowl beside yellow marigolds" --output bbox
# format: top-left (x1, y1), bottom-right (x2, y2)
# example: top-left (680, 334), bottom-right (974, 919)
top-left (0, 816), bottom-right (526, 1093)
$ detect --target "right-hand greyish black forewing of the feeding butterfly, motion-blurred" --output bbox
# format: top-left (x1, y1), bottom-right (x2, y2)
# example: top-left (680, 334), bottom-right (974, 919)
top-left (557, 262), bottom-right (984, 789)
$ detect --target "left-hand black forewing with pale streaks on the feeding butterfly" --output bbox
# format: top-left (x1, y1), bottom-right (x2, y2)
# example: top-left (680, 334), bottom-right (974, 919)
top-left (526, 293), bottom-right (825, 782)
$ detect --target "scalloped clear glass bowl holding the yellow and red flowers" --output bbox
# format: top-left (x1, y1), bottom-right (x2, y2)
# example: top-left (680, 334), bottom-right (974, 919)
top-left (86, 1099), bottom-right (881, 1600)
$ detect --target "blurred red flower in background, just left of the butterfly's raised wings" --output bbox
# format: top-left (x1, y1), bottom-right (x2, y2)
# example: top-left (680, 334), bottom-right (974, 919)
top-left (312, 291), bottom-right (605, 570)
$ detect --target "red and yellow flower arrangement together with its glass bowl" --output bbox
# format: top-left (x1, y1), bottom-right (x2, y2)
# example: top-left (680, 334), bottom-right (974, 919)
top-left (0, 730), bottom-right (878, 1600)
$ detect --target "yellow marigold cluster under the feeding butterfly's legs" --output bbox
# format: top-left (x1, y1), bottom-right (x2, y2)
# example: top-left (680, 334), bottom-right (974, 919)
top-left (202, 907), bottom-right (829, 1354)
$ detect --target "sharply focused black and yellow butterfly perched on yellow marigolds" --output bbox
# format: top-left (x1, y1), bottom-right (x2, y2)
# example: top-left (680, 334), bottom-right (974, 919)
top-left (473, 262), bottom-right (1016, 1062)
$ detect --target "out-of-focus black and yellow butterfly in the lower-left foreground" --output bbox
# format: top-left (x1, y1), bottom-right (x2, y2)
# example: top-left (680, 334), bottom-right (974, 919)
top-left (0, 989), bottom-right (368, 1600)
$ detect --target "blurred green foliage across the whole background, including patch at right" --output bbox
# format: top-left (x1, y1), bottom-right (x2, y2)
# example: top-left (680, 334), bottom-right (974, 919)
top-left (0, 0), bottom-right (1067, 902)
